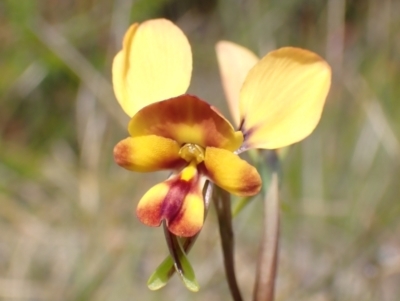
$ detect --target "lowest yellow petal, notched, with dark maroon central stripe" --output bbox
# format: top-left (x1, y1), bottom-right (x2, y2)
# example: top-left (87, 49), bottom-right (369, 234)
top-left (136, 164), bottom-right (204, 237)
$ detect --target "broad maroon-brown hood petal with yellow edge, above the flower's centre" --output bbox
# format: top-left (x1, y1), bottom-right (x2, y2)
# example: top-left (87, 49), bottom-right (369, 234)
top-left (129, 94), bottom-right (243, 151)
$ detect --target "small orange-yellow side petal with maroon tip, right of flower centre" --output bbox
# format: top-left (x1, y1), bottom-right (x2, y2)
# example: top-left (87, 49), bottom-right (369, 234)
top-left (204, 147), bottom-right (261, 196)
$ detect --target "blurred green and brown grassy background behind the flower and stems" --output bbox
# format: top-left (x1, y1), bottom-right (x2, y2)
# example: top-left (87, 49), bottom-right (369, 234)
top-left (0, 0), bottom-right (400, 301)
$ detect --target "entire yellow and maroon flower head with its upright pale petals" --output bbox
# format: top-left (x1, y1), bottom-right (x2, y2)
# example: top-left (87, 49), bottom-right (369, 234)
top-left (113, 19), bottom-right (331, 237)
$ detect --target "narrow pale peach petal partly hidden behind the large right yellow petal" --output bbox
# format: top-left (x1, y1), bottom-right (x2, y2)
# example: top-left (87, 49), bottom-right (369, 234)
top-left (215, 41), bottom-right (259, 126)
